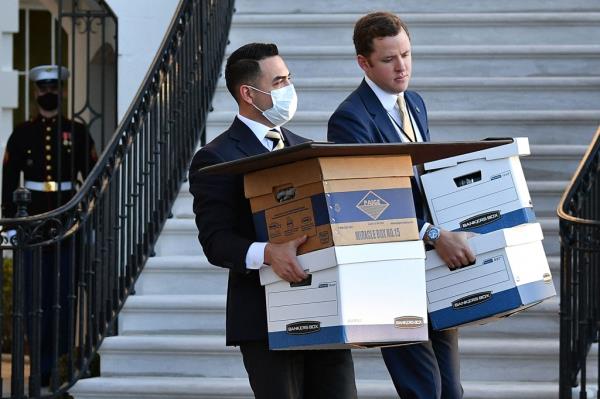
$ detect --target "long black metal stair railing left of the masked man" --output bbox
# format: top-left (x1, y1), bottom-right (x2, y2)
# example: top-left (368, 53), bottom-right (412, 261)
top-left (0, 0), bottom-right (233, 398)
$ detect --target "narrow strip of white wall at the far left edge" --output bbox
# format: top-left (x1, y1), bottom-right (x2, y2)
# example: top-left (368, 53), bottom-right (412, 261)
top-left (0, 0), bottom-right (19, 154)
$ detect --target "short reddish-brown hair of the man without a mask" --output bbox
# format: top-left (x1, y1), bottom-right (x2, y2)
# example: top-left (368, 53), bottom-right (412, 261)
top-left (352, 11), bottom-right (410, 57)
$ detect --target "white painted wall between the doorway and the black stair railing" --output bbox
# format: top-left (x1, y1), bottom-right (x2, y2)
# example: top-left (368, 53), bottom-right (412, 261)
top-left (105, 0), bottom-right (180, 121)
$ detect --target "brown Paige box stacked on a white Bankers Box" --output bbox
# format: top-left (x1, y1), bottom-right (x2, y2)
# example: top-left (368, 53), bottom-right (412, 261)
top-left (244, 155), bottom-right (428, 349)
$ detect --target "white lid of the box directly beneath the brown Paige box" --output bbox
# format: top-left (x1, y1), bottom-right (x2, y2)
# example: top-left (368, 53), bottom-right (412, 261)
top-left (259, 240), bottom-right (425, 285)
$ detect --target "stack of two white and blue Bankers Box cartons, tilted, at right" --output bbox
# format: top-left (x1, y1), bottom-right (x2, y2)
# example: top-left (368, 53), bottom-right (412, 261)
top-left (421, 138), bottom-right (556, 329)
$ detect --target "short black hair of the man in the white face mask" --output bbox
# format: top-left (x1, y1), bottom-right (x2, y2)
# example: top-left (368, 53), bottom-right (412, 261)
top-left (225, 43), bottom-right (279, 101)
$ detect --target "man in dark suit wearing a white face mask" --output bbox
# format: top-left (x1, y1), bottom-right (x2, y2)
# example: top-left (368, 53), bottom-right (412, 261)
top-left (190, 43), bottom-right (356, 399)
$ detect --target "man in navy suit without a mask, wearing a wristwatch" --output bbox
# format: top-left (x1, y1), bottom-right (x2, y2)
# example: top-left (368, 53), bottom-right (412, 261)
top-left (327, 12), bottom-right (475, 399)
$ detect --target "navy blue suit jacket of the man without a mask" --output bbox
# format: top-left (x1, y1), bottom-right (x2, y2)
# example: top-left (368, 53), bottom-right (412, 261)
top-left (327, 79), bottom-right (429, 229)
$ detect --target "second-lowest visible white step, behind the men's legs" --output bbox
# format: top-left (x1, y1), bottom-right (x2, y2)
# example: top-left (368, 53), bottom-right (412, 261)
top-left (101, 335), bottom-right (584, 382)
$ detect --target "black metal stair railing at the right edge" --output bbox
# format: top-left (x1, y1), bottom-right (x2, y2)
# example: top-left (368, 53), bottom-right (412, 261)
top-left (557, 128), bottom-right (600, 399)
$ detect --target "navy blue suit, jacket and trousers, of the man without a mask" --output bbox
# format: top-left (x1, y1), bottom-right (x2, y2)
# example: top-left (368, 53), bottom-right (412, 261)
top-left (327, 81), bottom-right (463, 398)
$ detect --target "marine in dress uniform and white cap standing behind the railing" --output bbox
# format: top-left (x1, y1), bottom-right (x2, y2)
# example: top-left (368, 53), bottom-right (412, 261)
top-left (2, 65), bottom-right (98, 386)
